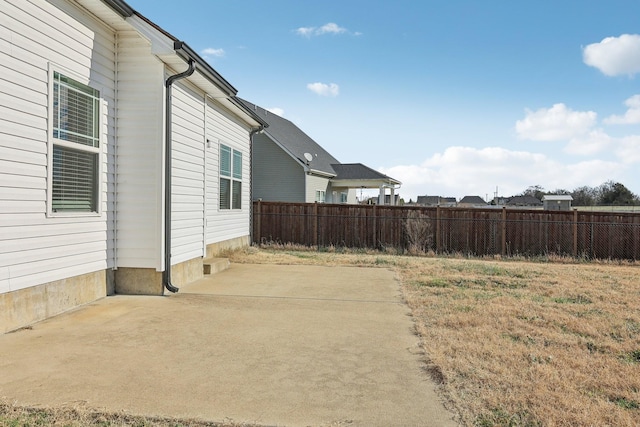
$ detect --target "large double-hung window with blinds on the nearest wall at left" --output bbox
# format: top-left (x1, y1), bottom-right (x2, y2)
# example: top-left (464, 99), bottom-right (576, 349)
top-left (50, 72), bottom-right (100, 212)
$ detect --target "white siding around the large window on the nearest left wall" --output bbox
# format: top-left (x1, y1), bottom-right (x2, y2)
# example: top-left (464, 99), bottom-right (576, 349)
top-left (0, 0), bottom-right (115, 292)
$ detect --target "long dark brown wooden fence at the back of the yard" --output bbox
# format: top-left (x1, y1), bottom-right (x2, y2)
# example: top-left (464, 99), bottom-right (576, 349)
top-left (253, 201), bottom-right (640, 260)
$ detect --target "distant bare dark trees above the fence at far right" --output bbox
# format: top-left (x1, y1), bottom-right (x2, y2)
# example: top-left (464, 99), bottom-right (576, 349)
top-left (518, 181), bottom-right (640, 206)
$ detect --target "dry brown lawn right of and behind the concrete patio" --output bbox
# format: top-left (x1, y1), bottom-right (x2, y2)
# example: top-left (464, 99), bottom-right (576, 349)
top-left (230, 247), bottom-right (640, 426)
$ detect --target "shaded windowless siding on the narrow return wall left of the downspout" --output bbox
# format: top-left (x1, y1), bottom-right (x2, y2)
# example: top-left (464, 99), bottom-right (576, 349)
top-left (117, 31), bottom-right (165, 271)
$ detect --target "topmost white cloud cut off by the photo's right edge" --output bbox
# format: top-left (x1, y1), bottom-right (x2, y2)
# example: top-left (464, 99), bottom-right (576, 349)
top-left (582, 34), bottom-right (640, 76)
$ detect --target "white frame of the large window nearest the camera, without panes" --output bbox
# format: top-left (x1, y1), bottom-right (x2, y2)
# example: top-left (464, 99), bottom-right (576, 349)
top-left (47, 63), bottom-right (104, 217)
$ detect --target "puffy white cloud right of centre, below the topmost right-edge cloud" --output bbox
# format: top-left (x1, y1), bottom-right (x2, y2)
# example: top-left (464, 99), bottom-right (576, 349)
top-left (516, 103), bottom-right (597, 141)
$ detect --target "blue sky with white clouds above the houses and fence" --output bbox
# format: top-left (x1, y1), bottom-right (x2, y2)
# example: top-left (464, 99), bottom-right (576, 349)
top-left (128, 0), bottom-right (640, 200)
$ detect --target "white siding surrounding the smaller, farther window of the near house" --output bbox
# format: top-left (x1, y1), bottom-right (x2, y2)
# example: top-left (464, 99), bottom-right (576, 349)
top-left (206, 100), bottom-right (251, 244)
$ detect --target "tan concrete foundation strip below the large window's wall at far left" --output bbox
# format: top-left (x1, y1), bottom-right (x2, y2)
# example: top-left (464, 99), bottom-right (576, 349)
top-left (0, 270), bottom-right (110, 334)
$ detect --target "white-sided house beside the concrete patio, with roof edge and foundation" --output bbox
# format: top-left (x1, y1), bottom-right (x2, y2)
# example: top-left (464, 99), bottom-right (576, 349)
top-left (0, 0), bottom-right (266, 333)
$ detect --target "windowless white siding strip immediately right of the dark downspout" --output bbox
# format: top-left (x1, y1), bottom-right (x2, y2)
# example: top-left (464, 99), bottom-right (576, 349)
top-left (171, 82), bottom-right (205, 264)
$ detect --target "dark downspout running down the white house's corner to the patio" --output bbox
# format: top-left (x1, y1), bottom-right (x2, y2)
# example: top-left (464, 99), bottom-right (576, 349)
top-left (162, 59), bottom-right (196, 293)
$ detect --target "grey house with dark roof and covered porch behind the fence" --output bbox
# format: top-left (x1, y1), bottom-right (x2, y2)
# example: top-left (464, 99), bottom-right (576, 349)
top-left (243, 100), bottom-right (401, 204)
